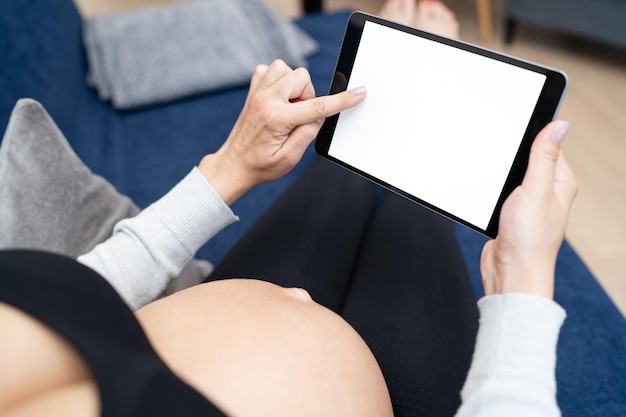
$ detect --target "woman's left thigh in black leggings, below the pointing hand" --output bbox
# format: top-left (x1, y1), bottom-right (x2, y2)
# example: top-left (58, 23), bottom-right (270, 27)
top-left (208, 159), bottom-right (375, 312)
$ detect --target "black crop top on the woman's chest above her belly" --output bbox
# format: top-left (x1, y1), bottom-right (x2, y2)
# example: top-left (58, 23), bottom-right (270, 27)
top-left (0, 250), bottom-right (224, 417)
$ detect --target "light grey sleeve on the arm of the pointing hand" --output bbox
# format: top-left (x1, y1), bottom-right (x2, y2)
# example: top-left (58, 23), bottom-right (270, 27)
top-left (78, 168), bottom-right (237, 309)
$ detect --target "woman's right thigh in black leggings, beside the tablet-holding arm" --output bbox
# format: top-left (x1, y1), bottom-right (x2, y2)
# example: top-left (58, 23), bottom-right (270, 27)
top-left (341, 194), bottom-right (478, 416)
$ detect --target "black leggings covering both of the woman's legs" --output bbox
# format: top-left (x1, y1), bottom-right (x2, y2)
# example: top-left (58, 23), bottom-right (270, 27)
top-left (208, 160), bottom-right (478, 416)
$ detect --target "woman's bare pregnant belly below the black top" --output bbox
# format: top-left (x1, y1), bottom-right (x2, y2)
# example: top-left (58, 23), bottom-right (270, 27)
top-left (137, 279), bottom-right (392, 417)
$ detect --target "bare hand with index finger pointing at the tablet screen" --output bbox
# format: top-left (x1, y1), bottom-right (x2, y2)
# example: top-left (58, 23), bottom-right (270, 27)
top-left (199, 60), bottom-right (365, 204)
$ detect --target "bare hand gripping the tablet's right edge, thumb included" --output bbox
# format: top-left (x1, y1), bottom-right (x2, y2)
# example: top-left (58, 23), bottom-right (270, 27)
top-left (480, 122), bottom-right (578, 298)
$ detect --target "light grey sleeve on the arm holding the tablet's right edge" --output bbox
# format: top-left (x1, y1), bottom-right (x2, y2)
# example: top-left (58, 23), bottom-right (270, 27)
top-left (457, 294), bottom-right (566, 417)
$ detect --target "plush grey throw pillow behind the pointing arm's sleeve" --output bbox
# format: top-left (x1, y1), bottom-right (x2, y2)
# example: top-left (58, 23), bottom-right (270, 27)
top-left (0, 99), bottom-right (212, 292)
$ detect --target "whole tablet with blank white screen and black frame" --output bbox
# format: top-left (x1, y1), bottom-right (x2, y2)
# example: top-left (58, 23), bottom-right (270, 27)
top-left (315, 12), bottom-right (568, 237)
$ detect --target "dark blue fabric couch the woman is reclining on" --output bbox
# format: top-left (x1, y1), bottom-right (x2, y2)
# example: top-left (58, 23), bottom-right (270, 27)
top-left (0, 0), bottom-right (626, 417)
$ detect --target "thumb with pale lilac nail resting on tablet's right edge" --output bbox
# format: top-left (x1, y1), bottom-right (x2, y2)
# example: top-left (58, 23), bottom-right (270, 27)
top-left (522, 121), bottom-right (569, 191)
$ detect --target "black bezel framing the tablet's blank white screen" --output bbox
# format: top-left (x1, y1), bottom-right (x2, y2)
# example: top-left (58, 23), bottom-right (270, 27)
top-left (315, 12), bottom-right (568, 238)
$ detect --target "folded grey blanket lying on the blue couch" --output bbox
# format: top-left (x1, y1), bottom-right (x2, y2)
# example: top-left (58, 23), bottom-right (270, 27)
top-left (83, 0), bottom-right (318, 109)
